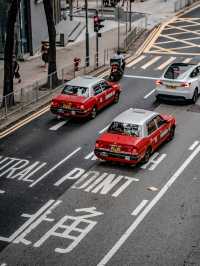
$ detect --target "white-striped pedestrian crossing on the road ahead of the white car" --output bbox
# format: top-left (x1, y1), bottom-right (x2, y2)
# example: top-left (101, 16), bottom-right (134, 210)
top-left (126, 54), bottom-right (200, 71)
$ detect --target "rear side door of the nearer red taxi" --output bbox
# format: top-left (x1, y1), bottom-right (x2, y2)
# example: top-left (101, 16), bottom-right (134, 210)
top-left (146, 118), bottom-right (160, 150)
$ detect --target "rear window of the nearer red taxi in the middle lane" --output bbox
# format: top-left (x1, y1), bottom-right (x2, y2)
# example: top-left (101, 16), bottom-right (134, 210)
top-left (108, 122), bottom-right (140, 137)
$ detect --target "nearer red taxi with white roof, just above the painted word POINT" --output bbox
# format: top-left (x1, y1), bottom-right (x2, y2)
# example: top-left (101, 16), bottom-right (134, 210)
top-left (94, 108), bottom-right (176, 164)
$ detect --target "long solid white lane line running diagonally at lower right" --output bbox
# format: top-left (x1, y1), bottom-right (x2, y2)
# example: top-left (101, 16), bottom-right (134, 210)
top-left (97, 145), bottom-right (200, 266)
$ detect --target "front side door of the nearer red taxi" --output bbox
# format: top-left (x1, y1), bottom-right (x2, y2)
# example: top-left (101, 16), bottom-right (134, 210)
top-left (154, 115), bottom-right (169, 146)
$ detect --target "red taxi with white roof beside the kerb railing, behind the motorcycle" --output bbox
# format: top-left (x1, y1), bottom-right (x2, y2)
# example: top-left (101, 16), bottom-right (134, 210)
top-left (50, 76), bottom-right (121, 118)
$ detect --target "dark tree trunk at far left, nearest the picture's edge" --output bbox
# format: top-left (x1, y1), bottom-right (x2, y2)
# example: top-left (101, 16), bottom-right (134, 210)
top-left (3, 0), bottom-right (21, 105)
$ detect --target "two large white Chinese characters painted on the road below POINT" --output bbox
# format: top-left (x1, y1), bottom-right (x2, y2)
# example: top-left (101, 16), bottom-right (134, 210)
top-left (0, 200), bottom-right (103, 253)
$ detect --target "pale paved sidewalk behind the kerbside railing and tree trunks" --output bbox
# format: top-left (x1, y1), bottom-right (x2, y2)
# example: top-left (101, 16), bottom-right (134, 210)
top-left (0, 0), bottom-right (197, 131)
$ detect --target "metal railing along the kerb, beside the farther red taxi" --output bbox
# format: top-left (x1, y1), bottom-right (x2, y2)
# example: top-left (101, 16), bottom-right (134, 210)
top-left (0, 48), bottom-right (115, 121)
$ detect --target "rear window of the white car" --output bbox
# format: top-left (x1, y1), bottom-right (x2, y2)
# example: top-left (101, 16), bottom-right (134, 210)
top-left (164, 63), bottom-right (191, 79)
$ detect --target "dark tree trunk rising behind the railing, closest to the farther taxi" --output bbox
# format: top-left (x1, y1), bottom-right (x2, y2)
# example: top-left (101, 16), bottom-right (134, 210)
top-left (43, 0), bottom-right (58, 88)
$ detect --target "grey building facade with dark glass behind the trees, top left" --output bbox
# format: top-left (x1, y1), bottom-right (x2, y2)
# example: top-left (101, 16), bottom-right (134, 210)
top-left (0, 0), bottom-right (61, 58)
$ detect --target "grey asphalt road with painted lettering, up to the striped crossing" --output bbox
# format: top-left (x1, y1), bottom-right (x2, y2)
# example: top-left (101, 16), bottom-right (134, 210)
top-left (0, 8), bottom-right (200, 266)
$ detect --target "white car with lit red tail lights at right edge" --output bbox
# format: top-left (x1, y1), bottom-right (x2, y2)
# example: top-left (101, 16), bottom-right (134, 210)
top-left (155, 63), bottom-right (200, 103)
